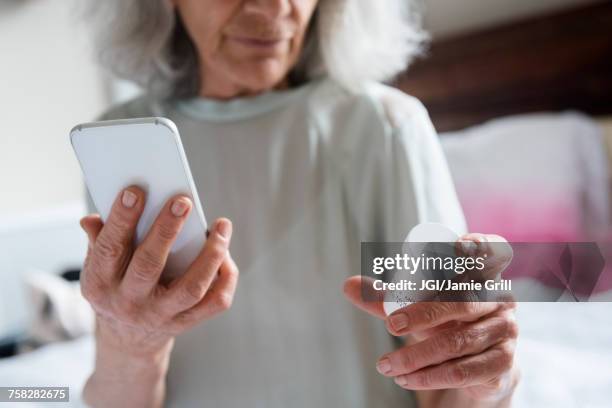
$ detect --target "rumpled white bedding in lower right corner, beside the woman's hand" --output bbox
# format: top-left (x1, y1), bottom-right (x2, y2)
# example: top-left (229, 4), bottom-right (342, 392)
top-left (514, 302), bottom-right (612, 408)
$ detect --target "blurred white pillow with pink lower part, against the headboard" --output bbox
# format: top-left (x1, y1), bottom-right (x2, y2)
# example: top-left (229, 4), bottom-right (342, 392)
top-left (441, 112), bottom-right (612, 291)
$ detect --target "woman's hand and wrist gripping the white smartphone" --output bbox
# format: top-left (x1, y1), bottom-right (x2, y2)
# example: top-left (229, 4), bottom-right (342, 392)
top-left (81, 186), bottom-right (238, 406)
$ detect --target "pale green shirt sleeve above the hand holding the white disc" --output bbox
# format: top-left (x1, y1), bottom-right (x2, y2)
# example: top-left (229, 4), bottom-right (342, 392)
top-left (346, 91), bottom-right (467, 242)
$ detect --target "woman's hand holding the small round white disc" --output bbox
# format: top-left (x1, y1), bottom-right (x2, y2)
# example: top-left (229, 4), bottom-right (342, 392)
top-left (344, 234), bottom-right (519, 402)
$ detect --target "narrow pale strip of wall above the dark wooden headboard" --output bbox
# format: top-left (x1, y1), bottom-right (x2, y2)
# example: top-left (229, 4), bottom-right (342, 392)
top-left (422, 0), bottom-right (597, 37)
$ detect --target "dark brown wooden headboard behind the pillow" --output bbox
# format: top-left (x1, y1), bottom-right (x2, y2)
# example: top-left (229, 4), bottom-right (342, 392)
top-left (396, 1), bottom-right (612, 131)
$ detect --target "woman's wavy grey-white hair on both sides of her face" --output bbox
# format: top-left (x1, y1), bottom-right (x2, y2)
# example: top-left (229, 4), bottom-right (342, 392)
top-left (89, 0), bottom-right (427, 98)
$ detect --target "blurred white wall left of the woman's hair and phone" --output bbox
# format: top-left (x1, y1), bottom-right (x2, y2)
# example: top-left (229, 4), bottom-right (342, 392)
top-left (0, 0), bottom-right (107, 220)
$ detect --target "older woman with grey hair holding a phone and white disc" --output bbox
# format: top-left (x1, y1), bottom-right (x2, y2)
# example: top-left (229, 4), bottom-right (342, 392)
top-left (82, 0), bottom-right (517, 407)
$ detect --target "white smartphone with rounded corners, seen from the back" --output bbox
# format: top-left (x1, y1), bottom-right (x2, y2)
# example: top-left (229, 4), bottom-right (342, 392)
top-left (70, 118), bottom-right (207, 279)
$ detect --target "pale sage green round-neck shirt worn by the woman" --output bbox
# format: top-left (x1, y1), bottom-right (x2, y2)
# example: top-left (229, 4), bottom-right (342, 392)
top-left (92, 79), bottom-right (465, 408)
